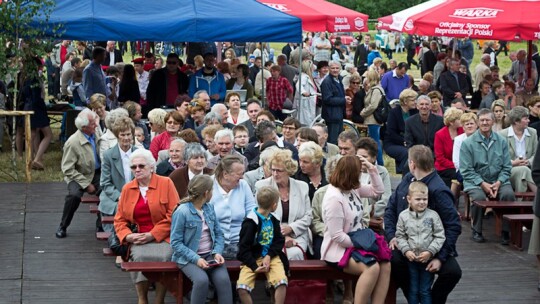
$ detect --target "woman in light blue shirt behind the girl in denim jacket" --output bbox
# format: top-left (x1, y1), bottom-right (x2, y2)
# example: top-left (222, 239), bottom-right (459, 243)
top-left (210, 155), bottom-right (256, 259)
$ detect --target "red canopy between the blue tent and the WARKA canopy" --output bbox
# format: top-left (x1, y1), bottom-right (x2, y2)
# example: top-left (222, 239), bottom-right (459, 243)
top-left (257, 0), bottom-right (368, 33)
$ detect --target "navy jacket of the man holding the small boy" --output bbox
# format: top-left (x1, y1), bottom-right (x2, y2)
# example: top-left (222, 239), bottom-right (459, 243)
top-left (384, 171), bottom-right (461, 262)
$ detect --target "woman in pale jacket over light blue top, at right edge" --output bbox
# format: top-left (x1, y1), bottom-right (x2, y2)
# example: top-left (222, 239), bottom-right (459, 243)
top-left (499, 106), bottom-right (538, 192)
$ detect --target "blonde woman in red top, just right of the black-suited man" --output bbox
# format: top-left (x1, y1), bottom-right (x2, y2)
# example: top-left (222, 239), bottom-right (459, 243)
top-left (433, 108), bottom-right (463, 188)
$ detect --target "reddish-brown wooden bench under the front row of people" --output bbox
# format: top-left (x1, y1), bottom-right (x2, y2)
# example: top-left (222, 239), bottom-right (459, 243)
top-left (122, 260), bottom-right (364, 303)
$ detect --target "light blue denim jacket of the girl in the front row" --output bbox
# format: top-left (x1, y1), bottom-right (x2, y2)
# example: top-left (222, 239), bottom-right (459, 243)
top-left (171, 202), bottom-right (223, 266)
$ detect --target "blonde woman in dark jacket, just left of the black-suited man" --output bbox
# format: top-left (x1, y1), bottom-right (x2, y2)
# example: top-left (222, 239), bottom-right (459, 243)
top-left (383, 89), bottom-right (418, 173)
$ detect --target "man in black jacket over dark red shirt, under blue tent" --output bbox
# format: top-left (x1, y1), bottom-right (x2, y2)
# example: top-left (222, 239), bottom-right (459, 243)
top-left (146, 53), bottom-right (189, 110)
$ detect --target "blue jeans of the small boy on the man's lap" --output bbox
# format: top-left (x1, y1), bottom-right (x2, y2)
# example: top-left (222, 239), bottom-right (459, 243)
top-left (408, 262), bottom-right (435, 304)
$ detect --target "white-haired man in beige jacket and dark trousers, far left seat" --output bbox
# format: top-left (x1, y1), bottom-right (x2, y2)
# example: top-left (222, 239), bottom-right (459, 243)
top-left (56, 109), bottom-right (101, 238)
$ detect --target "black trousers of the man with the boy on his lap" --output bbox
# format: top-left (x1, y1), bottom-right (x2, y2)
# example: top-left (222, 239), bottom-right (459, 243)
top-left (392, 250), bottom-right (461, 304)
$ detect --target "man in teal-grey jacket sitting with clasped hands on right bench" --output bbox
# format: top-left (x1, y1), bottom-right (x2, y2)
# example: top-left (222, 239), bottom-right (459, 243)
top-left (459, 109), bottom-right (516, 244)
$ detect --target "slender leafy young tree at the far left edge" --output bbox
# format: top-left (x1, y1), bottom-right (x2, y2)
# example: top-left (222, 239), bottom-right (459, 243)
top-left (0, 0), bottom-right (61, 180)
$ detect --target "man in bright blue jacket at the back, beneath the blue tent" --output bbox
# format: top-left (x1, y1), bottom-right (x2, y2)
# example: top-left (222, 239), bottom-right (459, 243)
top-left (189, 53), bottom-right (227, 105)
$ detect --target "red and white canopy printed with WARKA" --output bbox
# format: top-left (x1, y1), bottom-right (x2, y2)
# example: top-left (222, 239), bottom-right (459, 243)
top-left (378, 0), bottom-right (540, 40)
